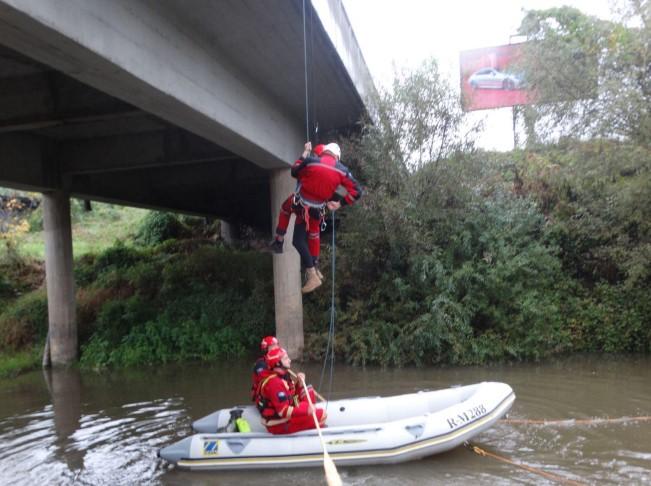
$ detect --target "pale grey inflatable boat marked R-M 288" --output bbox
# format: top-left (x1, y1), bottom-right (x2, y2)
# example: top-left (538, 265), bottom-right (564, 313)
top-left (158, 382), bottom-right (515, 470)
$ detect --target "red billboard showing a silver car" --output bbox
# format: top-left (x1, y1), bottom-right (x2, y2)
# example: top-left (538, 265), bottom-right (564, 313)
top-left (459, 43), bottom-right (535, 111)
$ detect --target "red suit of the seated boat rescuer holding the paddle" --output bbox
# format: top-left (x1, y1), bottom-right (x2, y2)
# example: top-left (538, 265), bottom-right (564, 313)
top-left (257, 368), bottom-right (325, 434)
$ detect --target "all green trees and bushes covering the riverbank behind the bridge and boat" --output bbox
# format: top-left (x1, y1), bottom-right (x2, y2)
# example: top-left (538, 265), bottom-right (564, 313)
top-left (0, 2), bottom-right (651, 374)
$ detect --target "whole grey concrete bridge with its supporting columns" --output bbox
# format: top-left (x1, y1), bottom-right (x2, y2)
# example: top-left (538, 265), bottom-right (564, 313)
top-left (0, 0), bottom-right (373, 365)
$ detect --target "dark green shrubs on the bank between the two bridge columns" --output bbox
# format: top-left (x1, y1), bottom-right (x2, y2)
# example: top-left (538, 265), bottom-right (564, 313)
top-left (79, 241), bottom-right (274, 367)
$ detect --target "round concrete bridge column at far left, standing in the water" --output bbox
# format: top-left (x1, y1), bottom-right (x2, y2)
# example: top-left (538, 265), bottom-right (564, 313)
top-left (43, 191), bottom-right (77, 366)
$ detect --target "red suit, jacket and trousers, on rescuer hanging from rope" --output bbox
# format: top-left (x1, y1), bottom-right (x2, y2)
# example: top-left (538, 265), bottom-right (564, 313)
top-left (276, 153), bottom-right (362, 268)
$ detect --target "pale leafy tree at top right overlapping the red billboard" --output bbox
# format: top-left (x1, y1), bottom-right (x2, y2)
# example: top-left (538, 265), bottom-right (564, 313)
top-left (519, 0), bottom-right (651, 147)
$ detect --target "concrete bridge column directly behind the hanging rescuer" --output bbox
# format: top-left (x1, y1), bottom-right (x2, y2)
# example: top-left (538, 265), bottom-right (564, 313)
top-left (270, 169), bottom-right (304, 359)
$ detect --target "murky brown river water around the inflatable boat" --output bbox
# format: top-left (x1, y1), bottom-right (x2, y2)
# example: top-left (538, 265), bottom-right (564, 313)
top-left (0, 356), bottom-right (651, 486)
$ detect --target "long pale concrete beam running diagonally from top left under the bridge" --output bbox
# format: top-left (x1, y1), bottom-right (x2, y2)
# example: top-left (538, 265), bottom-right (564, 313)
top-left (0, 0), bottom-right (304, 168)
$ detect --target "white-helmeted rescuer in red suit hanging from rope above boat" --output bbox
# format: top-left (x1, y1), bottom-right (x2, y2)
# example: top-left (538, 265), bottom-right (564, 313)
top-left (270, 142), bottom-right (362, 294)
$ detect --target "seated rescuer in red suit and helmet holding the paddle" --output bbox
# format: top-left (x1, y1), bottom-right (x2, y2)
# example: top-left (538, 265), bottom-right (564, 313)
top-left (257, 347), bottom-right (326, 434)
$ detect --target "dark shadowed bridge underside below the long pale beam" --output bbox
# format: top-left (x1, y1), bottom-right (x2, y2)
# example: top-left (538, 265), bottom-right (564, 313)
top-left (0, 47), bottom-right (271, 229)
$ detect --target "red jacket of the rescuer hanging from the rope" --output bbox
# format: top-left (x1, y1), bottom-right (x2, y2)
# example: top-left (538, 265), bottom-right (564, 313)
top-left (292, 154), bottom-right (362, 205)
